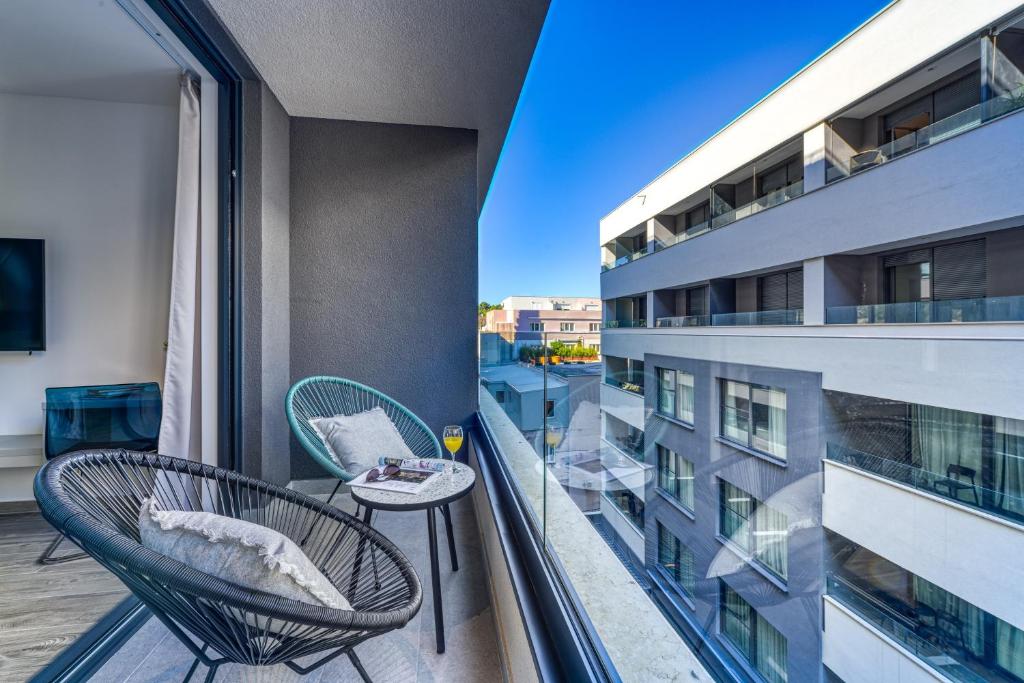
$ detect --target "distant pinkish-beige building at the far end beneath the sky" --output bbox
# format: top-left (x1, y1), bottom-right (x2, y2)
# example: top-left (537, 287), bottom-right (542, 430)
top-left (480, 296), bottom-right (602, 365)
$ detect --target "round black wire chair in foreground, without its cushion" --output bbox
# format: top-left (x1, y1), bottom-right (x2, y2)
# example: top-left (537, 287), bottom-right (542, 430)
top-left (35, 450), bottom-right (423, 683)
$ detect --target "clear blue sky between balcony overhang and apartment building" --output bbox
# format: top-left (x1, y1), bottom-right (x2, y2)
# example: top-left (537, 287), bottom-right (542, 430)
top-left (480, 0), bottom-right (887, 302)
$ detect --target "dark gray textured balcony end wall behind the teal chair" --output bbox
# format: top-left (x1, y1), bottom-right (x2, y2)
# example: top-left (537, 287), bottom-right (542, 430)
top-left (290, 118), bottom-right (477, 478)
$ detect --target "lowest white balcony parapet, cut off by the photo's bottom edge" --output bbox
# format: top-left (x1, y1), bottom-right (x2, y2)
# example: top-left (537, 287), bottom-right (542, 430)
top-left (821, 596), bottom-right (947, 683)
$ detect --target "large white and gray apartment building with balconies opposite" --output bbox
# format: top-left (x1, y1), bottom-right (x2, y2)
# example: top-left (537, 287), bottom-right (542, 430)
top-left (600, 0), bottom-right (1024, 683)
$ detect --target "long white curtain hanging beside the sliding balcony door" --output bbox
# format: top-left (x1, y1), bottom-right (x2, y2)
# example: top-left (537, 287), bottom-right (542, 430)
top-left (159, 76), bottom-right (202, 461)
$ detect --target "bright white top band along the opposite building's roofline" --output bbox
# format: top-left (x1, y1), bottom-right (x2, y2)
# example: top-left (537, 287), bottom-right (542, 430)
top-left (600, 0), bottom-right (1020, 245)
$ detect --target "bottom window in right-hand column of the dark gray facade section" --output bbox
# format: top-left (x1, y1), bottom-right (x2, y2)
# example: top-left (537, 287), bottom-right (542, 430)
top-left (718, 579), bottom-right (788, 683)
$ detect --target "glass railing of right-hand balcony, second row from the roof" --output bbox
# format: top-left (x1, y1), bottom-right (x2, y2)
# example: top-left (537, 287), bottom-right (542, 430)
top-left (825, 296), bottom-right (1024, 325)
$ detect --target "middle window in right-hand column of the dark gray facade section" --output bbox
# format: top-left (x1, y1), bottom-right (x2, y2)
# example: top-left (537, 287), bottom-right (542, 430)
top-left (718, 479), bottom-right (790, 581)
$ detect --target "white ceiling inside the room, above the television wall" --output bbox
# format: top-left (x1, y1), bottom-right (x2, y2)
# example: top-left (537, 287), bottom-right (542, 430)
top-left (0, 0), bottom-right (180, 104)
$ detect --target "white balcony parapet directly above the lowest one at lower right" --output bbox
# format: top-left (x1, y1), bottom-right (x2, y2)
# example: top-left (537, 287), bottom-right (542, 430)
top-left (822, 460), bottom-right (1024, 629)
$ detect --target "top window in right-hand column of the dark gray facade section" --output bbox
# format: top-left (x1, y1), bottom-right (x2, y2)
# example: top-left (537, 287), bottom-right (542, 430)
top-left (721, 380), bottom-right (786, 460)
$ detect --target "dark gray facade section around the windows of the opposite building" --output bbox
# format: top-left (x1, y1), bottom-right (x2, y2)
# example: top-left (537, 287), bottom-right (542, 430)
top-left (644, 354), bottom-right (824, 681)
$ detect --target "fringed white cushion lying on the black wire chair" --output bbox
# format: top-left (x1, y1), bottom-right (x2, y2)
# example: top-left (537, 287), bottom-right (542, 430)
top-left (138, 498), bottom-right (352, 610)
